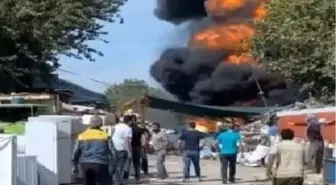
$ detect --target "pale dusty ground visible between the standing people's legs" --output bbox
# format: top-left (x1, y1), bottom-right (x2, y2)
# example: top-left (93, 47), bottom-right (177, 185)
top-left (136, 156), bottom-right (323, 185)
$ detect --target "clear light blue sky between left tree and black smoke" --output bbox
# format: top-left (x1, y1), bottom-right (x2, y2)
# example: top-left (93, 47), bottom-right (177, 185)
top-left (58, 0), bottom-right (188, 92)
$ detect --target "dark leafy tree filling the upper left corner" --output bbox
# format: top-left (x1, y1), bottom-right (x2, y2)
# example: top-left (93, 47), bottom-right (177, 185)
top-left (0, 0), bottom-right (126, 92)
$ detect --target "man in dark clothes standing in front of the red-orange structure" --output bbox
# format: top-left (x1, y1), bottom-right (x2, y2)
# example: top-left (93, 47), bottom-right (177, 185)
top-left (306, 114), bottom-right (324, 173)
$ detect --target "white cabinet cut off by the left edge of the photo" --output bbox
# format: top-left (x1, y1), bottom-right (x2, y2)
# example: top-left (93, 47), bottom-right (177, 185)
top-left (0, 134), bottom-right (16, 185)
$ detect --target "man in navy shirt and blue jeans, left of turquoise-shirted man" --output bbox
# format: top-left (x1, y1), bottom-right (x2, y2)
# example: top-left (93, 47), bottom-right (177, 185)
top-left (179, 122), bottom-right (205, 182)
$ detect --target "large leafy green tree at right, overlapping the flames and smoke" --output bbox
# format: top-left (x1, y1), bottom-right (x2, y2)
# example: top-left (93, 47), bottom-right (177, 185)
top-left (252, 0), bottom-right (336, 97)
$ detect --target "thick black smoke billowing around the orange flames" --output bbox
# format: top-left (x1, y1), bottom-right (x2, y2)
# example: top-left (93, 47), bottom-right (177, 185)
top-left (150, 0), bottom-right (302, 106)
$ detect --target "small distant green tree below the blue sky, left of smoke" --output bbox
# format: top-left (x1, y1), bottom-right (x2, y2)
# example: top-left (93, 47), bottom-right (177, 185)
top-left (105, 79), bottom-right (160, 105)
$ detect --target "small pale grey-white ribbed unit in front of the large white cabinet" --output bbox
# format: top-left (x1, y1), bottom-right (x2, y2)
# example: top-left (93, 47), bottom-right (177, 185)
top-left (16, 154), bottom-right (38, 185)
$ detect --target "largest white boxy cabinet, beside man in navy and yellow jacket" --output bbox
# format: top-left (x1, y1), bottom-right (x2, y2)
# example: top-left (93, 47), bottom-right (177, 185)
top-left (26, 116), bottom-right (86, 185)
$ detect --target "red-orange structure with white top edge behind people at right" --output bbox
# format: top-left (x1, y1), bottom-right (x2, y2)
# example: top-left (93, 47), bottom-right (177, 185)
top-left (277, 107), bottom-right (336, 142)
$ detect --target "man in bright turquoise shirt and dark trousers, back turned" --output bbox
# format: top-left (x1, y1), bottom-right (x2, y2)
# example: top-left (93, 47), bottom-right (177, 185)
top-left (217, 124), bottom-right (240, 184)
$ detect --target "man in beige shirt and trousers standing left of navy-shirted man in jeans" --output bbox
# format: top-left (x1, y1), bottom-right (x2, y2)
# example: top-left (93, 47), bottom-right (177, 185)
top-left (152, 123), bottom-right (169, 179)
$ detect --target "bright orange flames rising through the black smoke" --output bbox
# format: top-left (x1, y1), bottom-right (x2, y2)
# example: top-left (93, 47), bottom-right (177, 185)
top-left (186, 0), bottom-right (266, 130)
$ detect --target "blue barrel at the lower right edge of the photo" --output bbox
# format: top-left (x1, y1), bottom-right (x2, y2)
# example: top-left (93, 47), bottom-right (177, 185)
top-left (323, 158), bottom-right (336, 185)
